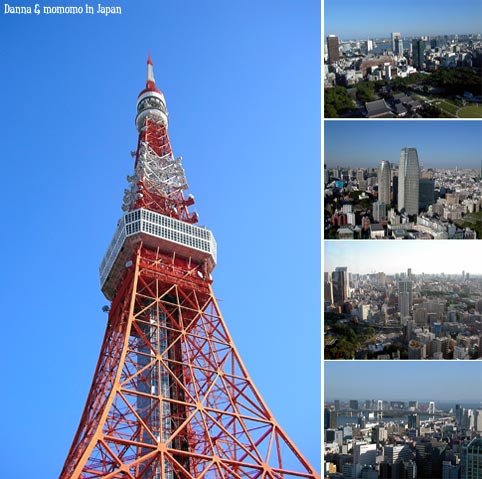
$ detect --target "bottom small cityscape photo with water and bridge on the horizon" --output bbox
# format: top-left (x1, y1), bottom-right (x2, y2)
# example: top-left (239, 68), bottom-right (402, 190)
top-left (323, 361), bottom-right (482, 479)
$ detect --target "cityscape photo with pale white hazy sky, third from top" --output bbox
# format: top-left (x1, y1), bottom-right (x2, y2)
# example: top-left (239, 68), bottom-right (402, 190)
top-left (323, 241), bottom-right (482, 360)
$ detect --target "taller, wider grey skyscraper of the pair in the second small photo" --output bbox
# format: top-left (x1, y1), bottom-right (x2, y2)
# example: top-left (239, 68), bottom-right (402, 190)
top-left (398, 148), bottom-right (420, 215)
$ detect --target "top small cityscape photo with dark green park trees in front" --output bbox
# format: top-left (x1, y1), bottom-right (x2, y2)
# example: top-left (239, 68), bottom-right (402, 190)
top-left (323, 0), bottom-right (482, 118)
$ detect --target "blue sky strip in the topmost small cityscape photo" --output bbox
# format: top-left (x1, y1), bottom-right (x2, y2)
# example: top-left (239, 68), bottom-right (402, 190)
top-left (324, 0), bottom-right (482, 40)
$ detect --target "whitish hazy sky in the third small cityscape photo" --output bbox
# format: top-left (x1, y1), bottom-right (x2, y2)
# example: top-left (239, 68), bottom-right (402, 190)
top-left (324, 240), bottom-right (482, 275)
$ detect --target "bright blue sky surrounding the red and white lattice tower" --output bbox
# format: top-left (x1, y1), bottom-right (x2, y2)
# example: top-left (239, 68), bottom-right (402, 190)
top-left (0, 0), bottom-right (321, 479)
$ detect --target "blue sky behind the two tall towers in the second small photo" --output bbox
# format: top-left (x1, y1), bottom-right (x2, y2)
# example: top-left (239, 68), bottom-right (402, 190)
top-left (324, 120), bottom-right (482, 169)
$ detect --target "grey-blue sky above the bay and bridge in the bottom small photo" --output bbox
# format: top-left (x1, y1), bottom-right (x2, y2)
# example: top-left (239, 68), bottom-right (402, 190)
top-left (324, 361), bottom-right (482, 401)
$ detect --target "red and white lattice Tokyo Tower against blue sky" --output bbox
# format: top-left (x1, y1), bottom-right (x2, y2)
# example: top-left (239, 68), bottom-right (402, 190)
top-left (60, 56), bottom-right (319, 479)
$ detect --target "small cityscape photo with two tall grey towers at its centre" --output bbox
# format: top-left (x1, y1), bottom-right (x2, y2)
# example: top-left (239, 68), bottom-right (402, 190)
top-left (323, 120), bottom-right (482, 239)
